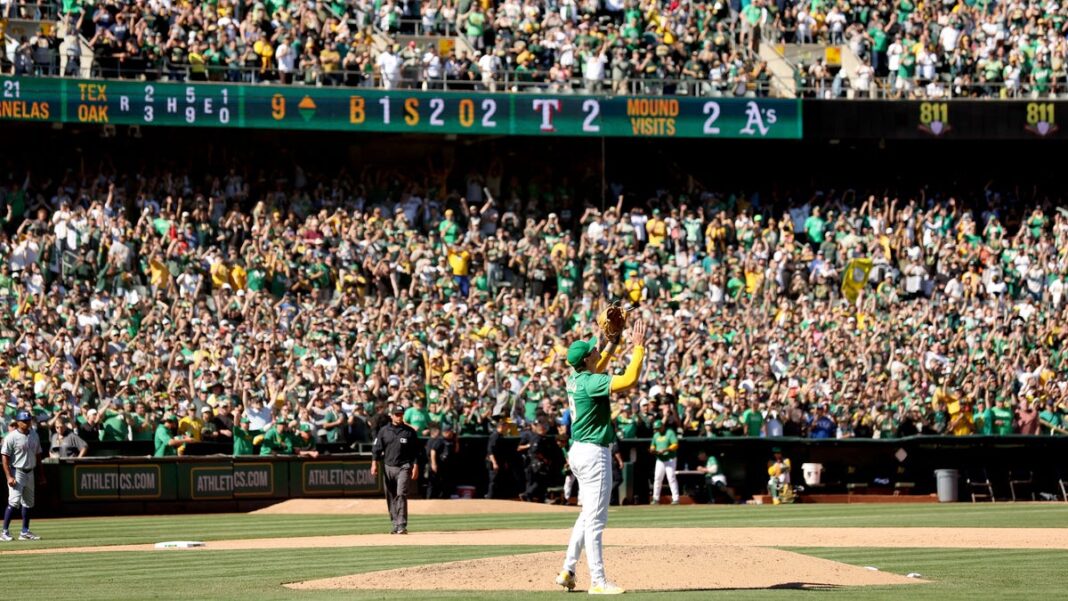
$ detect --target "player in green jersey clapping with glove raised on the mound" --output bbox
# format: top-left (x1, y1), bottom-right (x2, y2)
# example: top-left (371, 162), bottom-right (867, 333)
top-left (556, 307), bottom-right (645, 595)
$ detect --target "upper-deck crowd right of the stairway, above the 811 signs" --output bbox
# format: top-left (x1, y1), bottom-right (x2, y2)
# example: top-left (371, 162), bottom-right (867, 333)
top-left (798, 0), bottom-right (1068, 98)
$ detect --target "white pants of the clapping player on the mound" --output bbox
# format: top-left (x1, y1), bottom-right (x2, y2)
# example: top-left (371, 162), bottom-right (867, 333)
top-left (564, 442), bottom-right (612, 586)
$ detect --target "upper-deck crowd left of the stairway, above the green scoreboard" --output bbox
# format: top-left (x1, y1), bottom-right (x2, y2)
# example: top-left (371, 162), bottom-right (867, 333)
top-left (10, 0), bottom-right (769, 95)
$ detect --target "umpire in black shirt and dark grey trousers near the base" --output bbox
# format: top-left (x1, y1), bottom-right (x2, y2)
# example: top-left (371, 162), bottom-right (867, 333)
top-left (371, 404), bottom-right (423, 534)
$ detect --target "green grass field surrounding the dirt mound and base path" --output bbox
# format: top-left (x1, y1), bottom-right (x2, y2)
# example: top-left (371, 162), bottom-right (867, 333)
top-left (0, 504), bottom-right (1068, 601)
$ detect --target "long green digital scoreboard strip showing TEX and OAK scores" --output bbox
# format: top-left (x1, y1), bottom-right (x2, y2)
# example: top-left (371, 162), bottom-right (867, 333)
top-left (0, 78), bottom-right (802, 139)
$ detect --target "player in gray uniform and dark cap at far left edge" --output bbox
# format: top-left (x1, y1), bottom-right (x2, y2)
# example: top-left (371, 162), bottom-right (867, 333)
top-left (0, 411), bottom-right (43, 541)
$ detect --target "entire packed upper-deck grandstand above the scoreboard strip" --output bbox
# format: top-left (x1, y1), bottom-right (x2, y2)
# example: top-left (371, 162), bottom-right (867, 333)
top-left (0, 0), bottom-right (1068, 98)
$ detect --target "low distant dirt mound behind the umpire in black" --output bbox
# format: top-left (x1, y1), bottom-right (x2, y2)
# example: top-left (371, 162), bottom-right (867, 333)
top-left (253, 499), bottom-right (579, 517)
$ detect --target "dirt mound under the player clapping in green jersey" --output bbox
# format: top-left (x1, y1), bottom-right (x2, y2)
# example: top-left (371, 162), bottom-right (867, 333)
top-left (286, 544), bottom-right (924, 591)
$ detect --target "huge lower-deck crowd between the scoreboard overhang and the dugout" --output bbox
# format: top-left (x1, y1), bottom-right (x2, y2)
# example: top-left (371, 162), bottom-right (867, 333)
top-left (0, 153), bottom-right (1068, 465)
